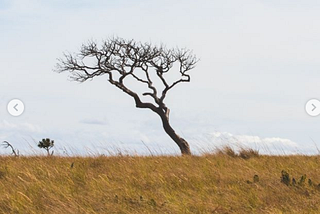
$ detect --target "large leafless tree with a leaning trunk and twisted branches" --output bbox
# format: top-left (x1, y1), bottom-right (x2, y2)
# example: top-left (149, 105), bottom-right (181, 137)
top-left (55, 38), bottom-right (198, 155)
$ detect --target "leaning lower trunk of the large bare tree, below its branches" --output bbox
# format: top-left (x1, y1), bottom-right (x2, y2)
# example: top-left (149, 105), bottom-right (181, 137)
top-left (158, 112), bottom-right (191, 155)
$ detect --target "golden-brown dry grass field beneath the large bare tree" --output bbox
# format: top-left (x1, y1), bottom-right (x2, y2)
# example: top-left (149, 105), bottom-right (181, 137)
top-left (0, 151), bottom-right (320, 214)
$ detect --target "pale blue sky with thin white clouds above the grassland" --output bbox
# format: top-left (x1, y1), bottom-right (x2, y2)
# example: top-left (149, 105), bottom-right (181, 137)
top-left (0, 0), bottom-right (320, 155)
